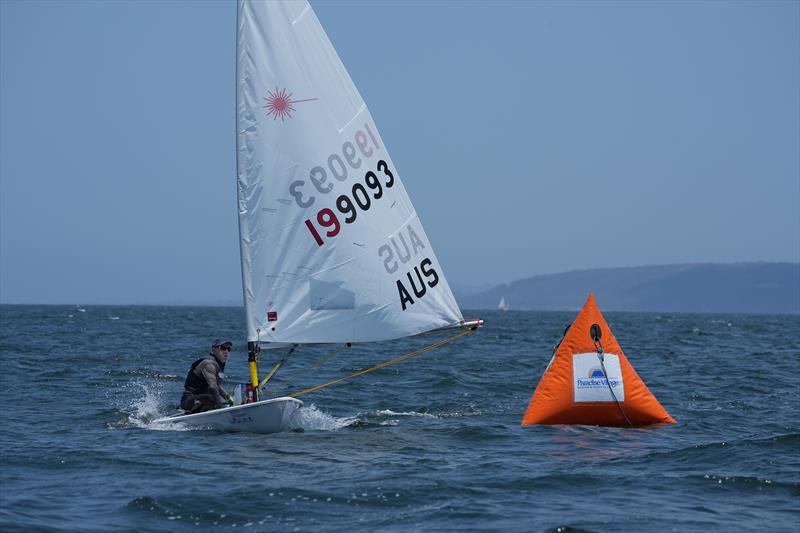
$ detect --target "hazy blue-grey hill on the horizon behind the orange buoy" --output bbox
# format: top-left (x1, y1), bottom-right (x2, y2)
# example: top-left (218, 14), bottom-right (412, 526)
top-left (457, 263), bottom-right (800, 313)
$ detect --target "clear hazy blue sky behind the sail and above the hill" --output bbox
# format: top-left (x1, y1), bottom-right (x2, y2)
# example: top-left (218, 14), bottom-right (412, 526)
top-left (0, 0), bottom-right (800, 304)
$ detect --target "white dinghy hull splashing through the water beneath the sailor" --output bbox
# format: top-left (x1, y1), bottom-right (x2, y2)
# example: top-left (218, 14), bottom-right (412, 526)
top-left (154, 397), bottom-right (303, 433)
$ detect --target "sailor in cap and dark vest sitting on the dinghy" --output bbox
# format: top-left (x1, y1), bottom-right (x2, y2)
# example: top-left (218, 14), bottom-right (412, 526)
top-left (181, 339), bottom-right (233, 413)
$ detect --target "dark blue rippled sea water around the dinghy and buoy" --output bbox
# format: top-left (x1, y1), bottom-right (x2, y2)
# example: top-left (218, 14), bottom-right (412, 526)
top-left (0, 306), bottom-right (800, 532)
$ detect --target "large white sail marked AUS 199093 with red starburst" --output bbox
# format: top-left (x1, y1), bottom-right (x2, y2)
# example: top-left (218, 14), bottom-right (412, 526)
top-left (236, 0), bottom-right (463, 343)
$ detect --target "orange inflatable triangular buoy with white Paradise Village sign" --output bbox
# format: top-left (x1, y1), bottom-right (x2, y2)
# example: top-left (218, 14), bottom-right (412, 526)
top-left (522, 294), bottom-right (675, 427)
